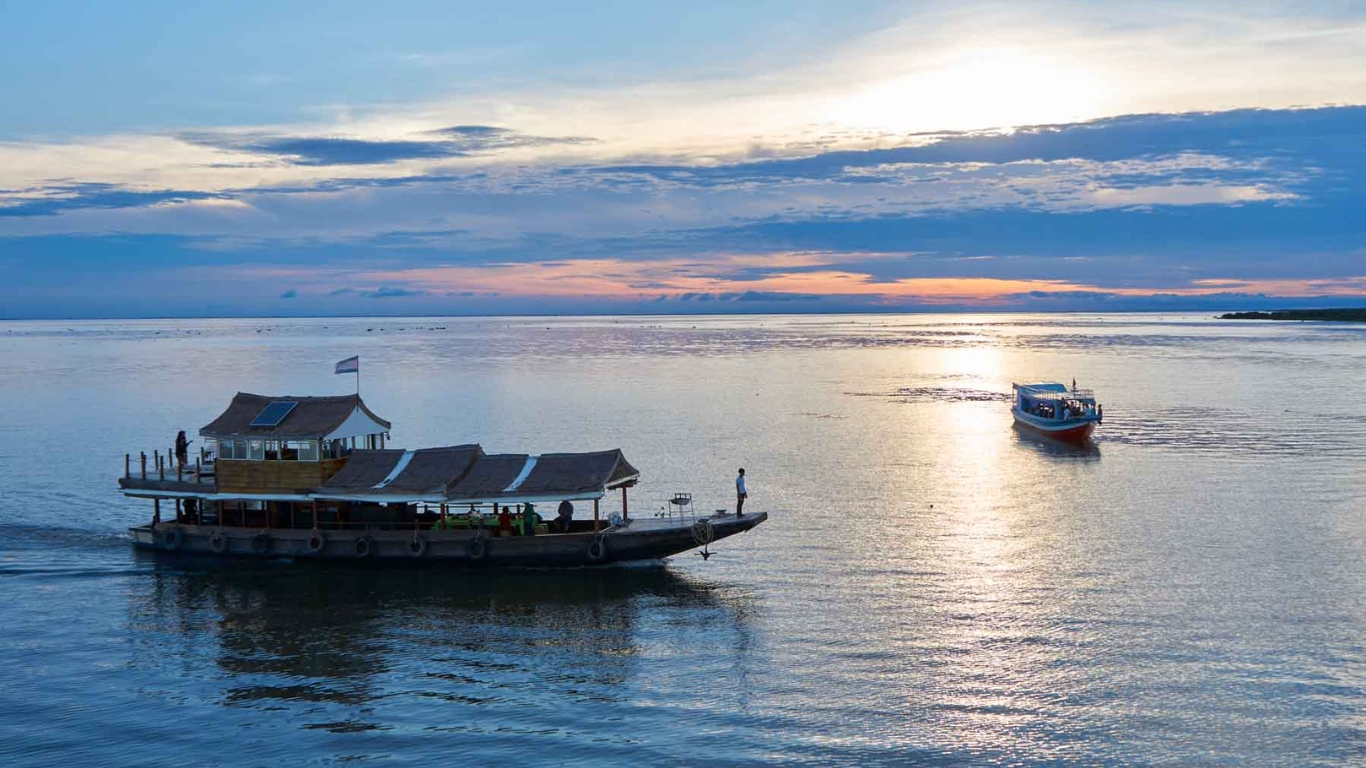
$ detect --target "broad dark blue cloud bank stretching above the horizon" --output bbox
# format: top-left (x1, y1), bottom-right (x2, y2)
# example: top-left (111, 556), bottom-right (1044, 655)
top-left (0, 107), bottom-right (1366, 312)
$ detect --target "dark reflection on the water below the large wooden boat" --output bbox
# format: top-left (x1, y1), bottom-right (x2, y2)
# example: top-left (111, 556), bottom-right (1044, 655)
top-left (128, 543), bottom-right (753, 737)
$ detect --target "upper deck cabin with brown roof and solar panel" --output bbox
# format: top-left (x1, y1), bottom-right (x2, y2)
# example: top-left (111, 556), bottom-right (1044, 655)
top-left (199, 392), bottom-right (391, 493)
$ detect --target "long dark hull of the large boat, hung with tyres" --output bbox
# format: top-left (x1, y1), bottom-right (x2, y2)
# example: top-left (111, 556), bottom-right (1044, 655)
top-left (130, 512), bottom-right (768, 567)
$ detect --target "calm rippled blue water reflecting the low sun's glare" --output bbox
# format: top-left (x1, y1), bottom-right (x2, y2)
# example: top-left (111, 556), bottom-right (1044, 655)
top-left (0, 316), bottom-right (1366, 767)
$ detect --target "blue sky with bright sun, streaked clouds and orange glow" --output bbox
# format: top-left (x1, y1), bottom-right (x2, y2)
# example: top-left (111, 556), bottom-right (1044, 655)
top-left (0, 0), bottom-right (1366, 318)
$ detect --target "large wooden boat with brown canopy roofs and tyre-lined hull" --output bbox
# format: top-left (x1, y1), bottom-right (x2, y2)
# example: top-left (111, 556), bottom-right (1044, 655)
top-left (119, 392), bottom-right (768, 567)
